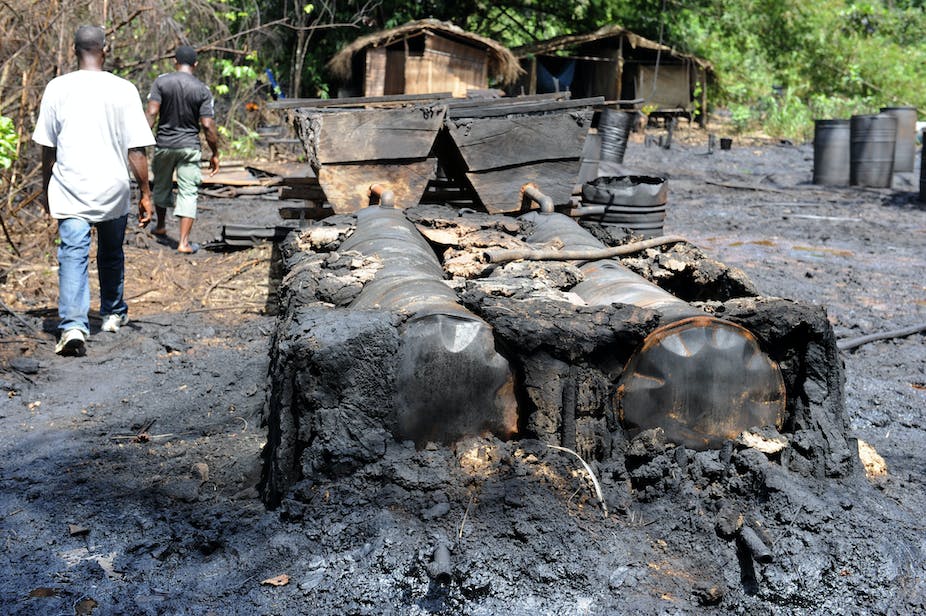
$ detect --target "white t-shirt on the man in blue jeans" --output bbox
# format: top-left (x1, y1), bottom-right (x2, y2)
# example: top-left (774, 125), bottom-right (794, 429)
top-left (32, 70), bottom-right (154, 222)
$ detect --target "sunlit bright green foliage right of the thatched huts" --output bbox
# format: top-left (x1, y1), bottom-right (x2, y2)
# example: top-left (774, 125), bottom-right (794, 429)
top-left (593, 0), bottom-right (926, 139)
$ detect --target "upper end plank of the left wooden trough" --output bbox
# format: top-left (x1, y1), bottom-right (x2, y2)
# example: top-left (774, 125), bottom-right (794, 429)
top-left (296, 105), bottom-right (447, 169)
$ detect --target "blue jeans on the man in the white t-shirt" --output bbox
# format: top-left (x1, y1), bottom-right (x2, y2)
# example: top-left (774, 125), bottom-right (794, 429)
top-left (58, 215), bottom-right (129, 334)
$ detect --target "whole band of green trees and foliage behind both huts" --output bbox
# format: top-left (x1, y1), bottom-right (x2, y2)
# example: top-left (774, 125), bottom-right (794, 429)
top-left (205, 0), bottom-right (926, 139)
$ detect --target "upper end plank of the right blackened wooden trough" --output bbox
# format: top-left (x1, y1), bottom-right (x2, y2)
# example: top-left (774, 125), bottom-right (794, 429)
top-left (446, 109), bottom-right (592, 171)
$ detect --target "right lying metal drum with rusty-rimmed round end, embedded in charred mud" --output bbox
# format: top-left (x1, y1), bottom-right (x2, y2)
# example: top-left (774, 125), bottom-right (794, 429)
top-left (525, 213), bottom-right (786, 450)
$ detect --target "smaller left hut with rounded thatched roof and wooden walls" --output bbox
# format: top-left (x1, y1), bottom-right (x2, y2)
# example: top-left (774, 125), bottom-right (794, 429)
top-left (328, 19), bottom-right (523, 96)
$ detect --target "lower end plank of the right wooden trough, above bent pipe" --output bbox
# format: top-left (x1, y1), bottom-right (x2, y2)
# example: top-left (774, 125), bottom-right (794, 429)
top-left (466, 158), bottom-right (579, 214)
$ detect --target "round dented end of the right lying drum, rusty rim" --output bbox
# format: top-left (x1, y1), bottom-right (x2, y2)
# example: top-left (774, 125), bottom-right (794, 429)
top-left (617, 316), bottom-right (785, 450)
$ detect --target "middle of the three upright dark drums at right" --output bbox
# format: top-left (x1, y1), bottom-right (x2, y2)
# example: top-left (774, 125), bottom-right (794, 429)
top-left (849, 113), bottom-right (897, 188)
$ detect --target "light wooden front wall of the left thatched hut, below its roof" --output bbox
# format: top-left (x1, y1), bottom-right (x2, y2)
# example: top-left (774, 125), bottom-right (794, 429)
top-left (362, 32), bottom-right (489, 96)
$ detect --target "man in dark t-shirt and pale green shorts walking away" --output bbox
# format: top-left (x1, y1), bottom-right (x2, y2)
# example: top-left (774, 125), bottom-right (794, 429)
top-left (146, 45), bottom-right (219, 254)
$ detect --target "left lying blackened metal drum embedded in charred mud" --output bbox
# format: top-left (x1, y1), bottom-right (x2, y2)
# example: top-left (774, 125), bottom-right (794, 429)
top-left (340, 207), bottom-right (517, 445)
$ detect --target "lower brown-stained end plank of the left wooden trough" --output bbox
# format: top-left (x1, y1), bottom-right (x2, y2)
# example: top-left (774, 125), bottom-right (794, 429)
top-left (318, 158), bottom-right (437, 214)
